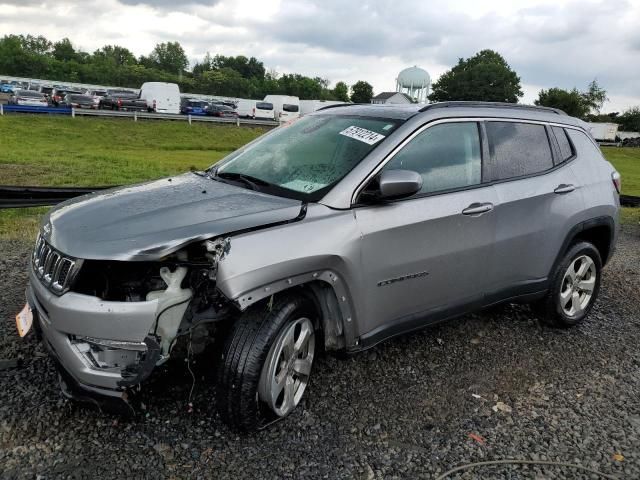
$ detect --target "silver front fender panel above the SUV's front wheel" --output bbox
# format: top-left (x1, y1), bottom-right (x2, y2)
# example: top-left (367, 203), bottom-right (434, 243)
top-left (216, 204), bottom-right (363, 345)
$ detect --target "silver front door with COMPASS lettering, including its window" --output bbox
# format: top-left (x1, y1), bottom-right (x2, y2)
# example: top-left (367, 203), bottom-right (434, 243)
top-left (354, 121), bottom-right (496, 343)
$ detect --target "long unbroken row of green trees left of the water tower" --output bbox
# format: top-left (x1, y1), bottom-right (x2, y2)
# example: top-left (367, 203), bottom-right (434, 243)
top-left (0, 35), bottom-right (357, 102)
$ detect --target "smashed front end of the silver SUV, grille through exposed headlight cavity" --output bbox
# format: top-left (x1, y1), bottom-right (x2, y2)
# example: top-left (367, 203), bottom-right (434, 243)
top-left (27, 234), bottom-right (235, 401)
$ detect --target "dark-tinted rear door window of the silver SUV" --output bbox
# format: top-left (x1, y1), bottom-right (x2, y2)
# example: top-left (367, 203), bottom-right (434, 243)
top-left (486, 122), bottom-right (553, 180)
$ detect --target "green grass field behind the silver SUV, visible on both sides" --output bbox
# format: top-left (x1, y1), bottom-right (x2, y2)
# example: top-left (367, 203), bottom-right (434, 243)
top-left (0, 115), bottom-right (640, 239)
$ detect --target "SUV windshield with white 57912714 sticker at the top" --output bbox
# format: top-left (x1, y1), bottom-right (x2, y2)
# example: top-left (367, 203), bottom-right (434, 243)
top-left (215, 115), bottom-right (399, 201)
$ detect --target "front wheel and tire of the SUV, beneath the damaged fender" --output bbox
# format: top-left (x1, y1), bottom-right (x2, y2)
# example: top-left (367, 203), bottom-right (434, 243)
top-left (217, 295), bottom-right (317, 431)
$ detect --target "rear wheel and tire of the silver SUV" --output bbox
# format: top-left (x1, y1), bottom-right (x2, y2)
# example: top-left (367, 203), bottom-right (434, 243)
top-left (532, 242), bottom-right (602, 328)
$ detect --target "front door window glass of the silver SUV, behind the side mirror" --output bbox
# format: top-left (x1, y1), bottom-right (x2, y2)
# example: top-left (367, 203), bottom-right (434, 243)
top-left (384, 122), bottom-right (482, 193)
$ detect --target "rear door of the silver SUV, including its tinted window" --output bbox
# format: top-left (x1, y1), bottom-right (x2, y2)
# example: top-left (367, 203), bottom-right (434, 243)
top-left (485, 120), bottom-right (582, 300)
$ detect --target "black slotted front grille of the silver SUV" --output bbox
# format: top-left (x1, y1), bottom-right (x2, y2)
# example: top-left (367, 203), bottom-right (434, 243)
top-left (31, 235), bottom-right (82, 295)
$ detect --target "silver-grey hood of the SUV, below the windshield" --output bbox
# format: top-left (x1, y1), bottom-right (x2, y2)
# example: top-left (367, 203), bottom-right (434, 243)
top-left (41, 173), bottom-right (302, 260)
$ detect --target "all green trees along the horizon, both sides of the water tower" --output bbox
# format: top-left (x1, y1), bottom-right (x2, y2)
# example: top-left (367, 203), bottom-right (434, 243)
top-left (0, 35), bottom-right (640, 131)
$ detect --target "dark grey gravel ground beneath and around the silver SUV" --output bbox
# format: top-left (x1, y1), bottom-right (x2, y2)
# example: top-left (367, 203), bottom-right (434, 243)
top-left (0, 226), bottom-right (640, 479)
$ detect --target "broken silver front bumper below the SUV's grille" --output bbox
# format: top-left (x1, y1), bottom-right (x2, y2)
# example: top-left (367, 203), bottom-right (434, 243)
top-left (26, 268), bottom-right (159, 398)
